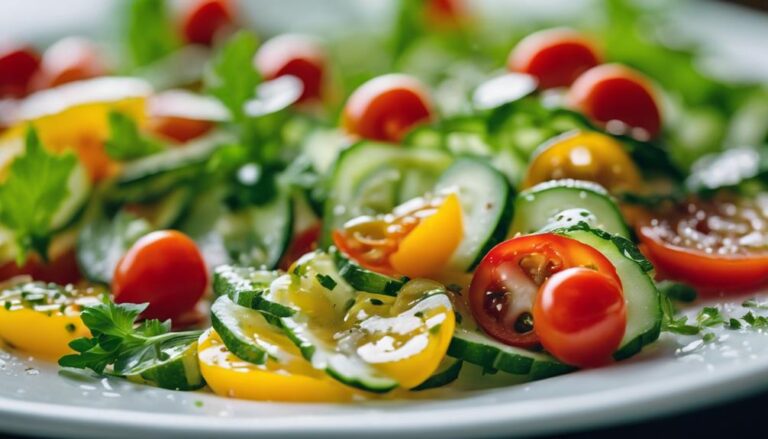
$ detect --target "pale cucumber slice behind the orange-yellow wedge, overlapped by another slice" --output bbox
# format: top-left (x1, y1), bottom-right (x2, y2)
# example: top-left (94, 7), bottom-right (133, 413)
top-left (321, 141), bottom-right (452, 248)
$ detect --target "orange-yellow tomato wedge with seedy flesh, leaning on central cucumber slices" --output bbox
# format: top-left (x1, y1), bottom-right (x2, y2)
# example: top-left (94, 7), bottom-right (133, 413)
top-left (333, 194), bottom-right (463, 278)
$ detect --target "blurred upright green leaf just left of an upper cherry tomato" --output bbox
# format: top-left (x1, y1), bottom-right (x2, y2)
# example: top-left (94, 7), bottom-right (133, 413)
top-left (204, 31), bottom-right (261, 121)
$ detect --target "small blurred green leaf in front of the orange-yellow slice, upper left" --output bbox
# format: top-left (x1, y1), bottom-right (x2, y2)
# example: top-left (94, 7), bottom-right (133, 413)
top-left (104, 111), bottom-right (163, 160)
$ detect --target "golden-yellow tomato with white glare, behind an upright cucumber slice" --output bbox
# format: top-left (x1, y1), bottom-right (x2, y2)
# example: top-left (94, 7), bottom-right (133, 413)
top-left (523, 131), bottom-right (642, 192)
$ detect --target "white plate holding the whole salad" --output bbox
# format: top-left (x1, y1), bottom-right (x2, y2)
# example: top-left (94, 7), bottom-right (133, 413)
top-left (0, 0), bottom-right (768, 438)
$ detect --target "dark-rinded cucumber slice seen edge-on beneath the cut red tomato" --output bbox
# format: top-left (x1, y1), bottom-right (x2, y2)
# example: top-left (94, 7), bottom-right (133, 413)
top-left (448, 328), bottom-right (574, 380)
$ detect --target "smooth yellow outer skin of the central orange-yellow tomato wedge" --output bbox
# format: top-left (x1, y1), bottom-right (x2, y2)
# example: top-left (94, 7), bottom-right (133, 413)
top-left (389, 194), bottom-right (464, 278)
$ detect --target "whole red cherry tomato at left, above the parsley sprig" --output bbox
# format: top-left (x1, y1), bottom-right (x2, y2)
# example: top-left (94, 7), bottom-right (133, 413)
top-left (112, 230), bottom-right (208, 319)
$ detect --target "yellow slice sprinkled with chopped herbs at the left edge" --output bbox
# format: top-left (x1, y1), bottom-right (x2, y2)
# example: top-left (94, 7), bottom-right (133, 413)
top-left (0, 282), bottom-right (99, 360)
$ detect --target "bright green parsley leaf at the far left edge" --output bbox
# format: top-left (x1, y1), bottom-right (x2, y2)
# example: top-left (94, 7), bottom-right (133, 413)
top-left (0, 128), bottom-right (77, 265)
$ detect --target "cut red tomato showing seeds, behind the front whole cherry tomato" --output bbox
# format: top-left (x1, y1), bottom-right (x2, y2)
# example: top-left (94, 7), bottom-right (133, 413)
top-left (469, 233), bottom-right (621, 349)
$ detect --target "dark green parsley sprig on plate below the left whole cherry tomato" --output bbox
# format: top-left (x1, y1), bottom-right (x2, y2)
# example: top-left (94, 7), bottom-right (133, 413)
top-left (59, 300), bottom-right (201, 382)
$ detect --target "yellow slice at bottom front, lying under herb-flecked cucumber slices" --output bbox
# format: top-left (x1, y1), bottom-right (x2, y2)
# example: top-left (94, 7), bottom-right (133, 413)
top-left (198, 329), bottom-right (356, 402)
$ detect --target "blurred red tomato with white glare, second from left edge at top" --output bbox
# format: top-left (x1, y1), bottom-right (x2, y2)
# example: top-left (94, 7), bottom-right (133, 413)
top-left (32, 37), bottom-right (107, 90)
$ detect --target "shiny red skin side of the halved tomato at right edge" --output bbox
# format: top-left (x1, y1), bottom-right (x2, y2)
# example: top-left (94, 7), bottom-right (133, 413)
top-left (636, 224), bottom-right (768, 296)
